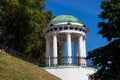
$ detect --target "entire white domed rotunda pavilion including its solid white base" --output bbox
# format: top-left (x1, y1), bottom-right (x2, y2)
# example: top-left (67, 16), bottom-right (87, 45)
top-left (45, 15), bottom-right (96, 80)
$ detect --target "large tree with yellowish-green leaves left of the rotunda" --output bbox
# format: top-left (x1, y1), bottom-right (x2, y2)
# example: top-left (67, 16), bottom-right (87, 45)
top-left (0, 0), bottom-right (52, 66)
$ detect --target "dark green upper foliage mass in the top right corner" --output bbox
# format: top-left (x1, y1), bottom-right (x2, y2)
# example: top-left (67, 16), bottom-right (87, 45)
top-left (99, 0), bottom-right (120, 41)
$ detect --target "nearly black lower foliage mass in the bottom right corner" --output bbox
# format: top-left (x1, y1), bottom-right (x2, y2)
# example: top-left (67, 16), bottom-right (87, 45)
top-left (89, 39), bottom-right (120, 80)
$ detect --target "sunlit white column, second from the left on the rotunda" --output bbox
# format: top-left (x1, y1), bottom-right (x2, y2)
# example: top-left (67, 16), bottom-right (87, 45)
top-left (53, 33), bottom-right (57, 65)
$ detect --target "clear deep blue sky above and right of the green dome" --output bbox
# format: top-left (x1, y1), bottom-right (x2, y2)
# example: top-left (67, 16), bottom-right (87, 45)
top-left (46, 0), bottom-right (107, 52)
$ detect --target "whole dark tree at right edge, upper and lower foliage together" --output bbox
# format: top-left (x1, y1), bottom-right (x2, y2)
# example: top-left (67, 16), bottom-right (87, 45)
top-left (88, 0), bottom-right (120, 80)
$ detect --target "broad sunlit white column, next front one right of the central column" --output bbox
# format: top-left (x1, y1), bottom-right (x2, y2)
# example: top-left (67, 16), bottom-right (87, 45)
top-left (79, 35), bottom-right (84, 65)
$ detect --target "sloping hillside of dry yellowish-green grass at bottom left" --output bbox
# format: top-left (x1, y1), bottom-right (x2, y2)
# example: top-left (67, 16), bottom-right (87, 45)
top-left (0, 53), bottom-right (60, 80)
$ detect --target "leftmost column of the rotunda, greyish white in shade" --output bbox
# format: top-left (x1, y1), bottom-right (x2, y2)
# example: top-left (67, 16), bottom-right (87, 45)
top-left (46, 38), bottom-right (50, 66)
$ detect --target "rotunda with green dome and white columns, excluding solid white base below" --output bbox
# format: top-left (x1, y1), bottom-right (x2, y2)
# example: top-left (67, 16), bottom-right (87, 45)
top-left (45, 15), bottom-right (88, 66)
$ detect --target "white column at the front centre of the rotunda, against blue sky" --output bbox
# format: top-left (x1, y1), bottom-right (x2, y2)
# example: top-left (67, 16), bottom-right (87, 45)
top-left (67, 33), bottom-right (72, 64)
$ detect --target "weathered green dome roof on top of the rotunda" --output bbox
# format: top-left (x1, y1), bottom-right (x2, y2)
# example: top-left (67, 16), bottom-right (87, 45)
top-left (50, 15), bottom-right (81, 24)
